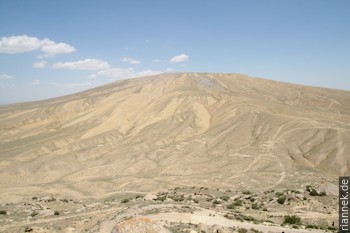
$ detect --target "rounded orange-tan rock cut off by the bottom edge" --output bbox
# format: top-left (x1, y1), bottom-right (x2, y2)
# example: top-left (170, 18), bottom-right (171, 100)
top-left (112, 218), bottom-right (170, 233)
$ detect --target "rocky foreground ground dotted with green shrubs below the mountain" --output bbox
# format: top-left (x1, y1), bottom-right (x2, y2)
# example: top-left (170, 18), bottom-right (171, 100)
top-left (0, 186), bottom-right (338, 233)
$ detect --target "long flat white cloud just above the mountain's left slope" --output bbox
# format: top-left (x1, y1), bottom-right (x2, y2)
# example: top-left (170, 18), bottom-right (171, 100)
top-left (52, 58), bottom-right (111, 70)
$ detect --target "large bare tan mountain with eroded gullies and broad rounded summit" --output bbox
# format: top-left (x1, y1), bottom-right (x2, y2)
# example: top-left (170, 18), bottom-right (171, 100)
top-left (0, 73), bottom-right (350, 202)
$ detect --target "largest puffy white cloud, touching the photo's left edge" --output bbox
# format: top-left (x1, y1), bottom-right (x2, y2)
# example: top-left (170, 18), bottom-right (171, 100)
top-left (0, 35), bottom-right (76, 57)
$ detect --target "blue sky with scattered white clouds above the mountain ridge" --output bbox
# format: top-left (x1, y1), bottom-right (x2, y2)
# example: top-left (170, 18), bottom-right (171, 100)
top-left (0, 0), bottom-right (350, 104)
